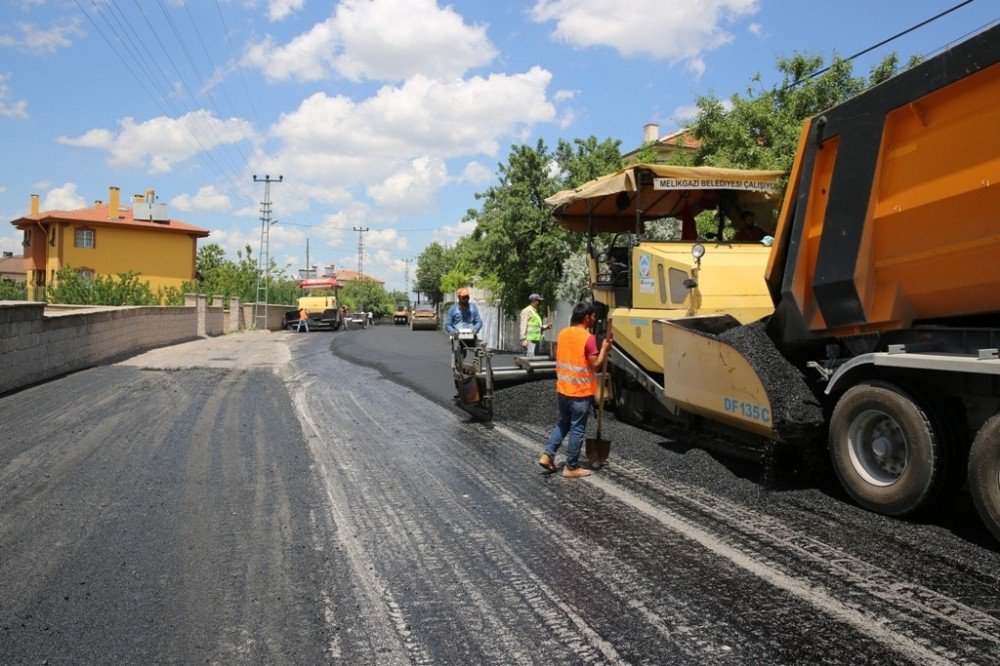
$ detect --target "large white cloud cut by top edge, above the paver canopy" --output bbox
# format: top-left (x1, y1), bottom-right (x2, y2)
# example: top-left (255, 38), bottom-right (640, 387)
top-left (531, 0), bottom-right (759, 74)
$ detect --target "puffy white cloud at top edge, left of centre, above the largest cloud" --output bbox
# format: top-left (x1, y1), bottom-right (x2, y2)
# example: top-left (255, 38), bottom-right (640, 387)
top-left (244, 0), bottom-right (497, 81)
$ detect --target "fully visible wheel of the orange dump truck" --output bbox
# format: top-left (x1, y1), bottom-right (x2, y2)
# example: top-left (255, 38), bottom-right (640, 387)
top-left (830, 381), bottom-right (954, 516)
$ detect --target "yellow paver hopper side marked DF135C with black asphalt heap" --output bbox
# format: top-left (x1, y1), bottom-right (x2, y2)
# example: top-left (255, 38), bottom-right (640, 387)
top-left (653, 315), bottom-right (824, 441)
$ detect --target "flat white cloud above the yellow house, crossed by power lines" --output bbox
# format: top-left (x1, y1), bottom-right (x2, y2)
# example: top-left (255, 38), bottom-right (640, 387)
top-left (58, 110), bottom-right (254, 174)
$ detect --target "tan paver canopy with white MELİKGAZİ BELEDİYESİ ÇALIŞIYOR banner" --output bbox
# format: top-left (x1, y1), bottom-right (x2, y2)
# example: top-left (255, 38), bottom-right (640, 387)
top-left (545, 164), bottom-right (786, 233)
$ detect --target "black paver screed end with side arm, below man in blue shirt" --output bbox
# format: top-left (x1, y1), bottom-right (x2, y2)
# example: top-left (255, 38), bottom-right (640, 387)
top-left (451, 331), bottom-right (556, 421)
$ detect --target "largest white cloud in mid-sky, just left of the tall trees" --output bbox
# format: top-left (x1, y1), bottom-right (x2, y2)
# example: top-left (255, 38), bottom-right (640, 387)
top-left (268, 68), bottom-right (555, 212)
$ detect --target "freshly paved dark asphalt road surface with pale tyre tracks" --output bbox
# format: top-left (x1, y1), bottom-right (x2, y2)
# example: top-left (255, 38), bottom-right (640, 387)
top-left (0, 326), bottom-right (1000, 664)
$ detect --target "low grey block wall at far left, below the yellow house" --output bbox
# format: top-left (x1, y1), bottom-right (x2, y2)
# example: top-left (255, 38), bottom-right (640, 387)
top-left (0, 301), bottom-right (198, 393)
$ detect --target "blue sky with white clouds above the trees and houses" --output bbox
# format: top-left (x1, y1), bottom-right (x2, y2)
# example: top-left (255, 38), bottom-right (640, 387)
top-left (0, 0), bottom-right (1000, 288)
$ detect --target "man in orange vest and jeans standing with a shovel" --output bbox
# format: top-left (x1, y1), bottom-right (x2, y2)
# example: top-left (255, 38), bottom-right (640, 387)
top-left (538, 303), bottom-right (611, 479)
